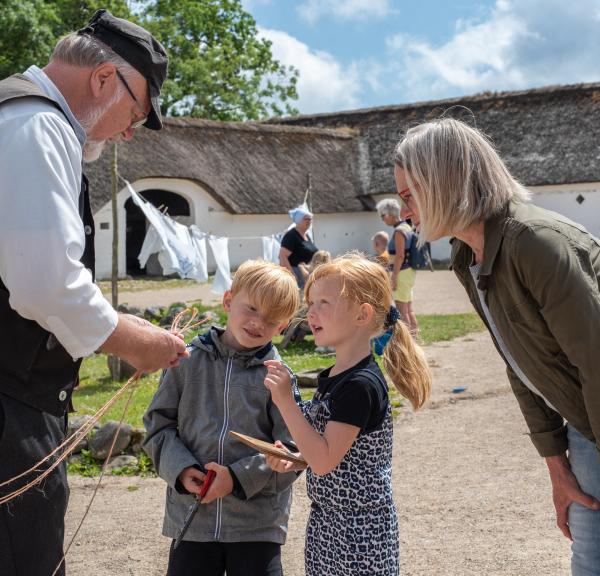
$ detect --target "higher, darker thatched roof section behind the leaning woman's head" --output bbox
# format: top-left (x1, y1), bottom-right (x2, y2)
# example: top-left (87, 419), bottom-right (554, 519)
top-left (270, 83), bottom-right (600, 194)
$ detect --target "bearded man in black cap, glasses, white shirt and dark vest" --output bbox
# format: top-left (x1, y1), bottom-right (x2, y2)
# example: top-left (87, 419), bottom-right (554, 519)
top-left (0, 10), bottom-right (186, 576)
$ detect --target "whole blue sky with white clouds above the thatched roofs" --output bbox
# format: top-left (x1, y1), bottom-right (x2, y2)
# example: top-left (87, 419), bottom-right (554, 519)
top-left (243, 0), bottom-right (600, 114)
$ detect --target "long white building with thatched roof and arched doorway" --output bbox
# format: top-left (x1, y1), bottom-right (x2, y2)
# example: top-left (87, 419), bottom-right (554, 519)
top-left (87, 84), bottom-right (600, 278)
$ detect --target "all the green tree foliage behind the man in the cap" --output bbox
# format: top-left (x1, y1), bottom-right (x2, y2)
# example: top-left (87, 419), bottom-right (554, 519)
top-left (0, 0), bottom-right (298, 120)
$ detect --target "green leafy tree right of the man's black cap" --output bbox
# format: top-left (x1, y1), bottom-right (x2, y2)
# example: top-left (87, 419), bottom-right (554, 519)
top-left (142, 0), bottom-right (298, 121)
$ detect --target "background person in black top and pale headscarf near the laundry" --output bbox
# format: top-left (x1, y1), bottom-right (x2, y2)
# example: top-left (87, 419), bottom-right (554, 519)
top-left (279, 207), bottom-right (318, 290)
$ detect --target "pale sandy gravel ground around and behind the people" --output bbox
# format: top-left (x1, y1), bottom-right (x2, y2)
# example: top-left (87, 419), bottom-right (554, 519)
top-left (67, 272), bottom-right (569, 576)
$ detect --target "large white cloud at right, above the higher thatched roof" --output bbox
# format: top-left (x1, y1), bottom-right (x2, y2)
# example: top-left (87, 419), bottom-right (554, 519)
top-left (387, 0), bottom-right (600, 100)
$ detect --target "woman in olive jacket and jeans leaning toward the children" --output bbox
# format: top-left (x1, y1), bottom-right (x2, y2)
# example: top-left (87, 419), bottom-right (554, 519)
top-left (394, 118), bottom-right (600, 576)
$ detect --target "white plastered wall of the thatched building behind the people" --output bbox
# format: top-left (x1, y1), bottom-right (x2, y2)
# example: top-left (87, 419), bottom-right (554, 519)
top-left (94, 178), bottom-right (600, 279)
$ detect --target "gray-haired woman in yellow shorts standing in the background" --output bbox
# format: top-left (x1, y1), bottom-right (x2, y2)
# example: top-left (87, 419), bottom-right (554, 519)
top-left (375, 198), bottom-right (419, 336)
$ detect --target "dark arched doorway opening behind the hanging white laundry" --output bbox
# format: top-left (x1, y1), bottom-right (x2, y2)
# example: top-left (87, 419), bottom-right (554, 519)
top-left (125, 190), bottom-right (191, 276)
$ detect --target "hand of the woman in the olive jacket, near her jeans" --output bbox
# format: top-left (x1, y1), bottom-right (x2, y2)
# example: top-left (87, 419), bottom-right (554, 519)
top-left (546, 454), bottom-right (600, 540)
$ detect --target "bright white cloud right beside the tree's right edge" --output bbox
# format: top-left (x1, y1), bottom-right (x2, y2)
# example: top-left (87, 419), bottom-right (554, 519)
top-left (259, 28), bottom-right (360, 114)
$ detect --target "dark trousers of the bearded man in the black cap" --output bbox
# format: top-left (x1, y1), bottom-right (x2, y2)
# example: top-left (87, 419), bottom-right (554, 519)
top-left (0, 394), bottom-right (69, 576)
